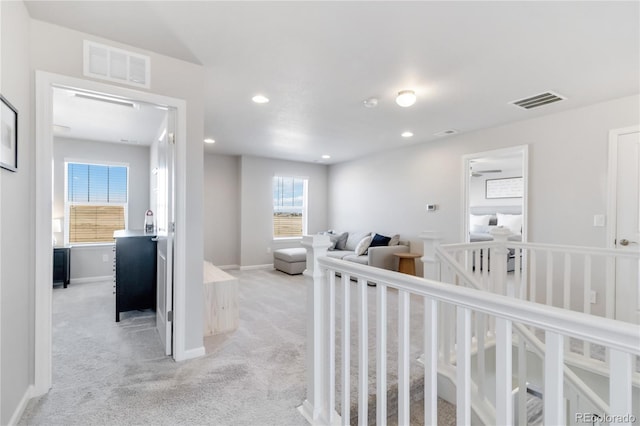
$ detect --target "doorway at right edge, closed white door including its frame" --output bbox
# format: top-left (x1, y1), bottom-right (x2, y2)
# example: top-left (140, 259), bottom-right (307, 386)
top-left (607, 126), bottom-right (640, 324)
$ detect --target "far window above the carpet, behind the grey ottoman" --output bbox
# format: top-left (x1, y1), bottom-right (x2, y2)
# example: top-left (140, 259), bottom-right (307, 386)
top-left (273, 176), bottom-right (307, 238)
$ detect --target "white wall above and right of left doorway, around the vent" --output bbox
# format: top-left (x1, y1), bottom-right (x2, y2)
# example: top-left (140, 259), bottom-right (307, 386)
top-left (29, 20), bottom-right (204, 350)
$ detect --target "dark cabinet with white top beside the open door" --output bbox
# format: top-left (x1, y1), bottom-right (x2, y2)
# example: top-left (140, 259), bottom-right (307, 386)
top-left (114, 230), bottom-right (157, 321)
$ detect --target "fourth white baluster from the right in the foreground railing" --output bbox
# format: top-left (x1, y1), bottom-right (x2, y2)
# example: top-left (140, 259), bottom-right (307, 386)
top-left (458, 306), bottom-right (471, 425)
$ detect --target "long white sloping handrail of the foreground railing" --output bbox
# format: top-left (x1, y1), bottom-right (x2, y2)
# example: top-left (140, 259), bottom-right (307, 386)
top-left (318, 251), bottom-right (640, 355)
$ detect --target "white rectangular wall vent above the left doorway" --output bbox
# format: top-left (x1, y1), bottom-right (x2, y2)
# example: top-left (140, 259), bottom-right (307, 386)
top-left (84, 40), bottom-right (151, 89)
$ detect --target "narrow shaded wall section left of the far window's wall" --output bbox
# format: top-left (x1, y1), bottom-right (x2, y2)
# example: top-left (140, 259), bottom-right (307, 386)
top-left (204, 154), bottom-right (240, 267)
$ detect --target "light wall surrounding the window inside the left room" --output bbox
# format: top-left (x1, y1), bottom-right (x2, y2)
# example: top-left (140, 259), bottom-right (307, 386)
top-left (53, 138), bottom-right (151, 280)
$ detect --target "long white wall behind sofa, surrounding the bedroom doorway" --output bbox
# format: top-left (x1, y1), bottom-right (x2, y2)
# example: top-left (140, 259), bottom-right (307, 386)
top-left (329, 95), bottom-right (639, 250)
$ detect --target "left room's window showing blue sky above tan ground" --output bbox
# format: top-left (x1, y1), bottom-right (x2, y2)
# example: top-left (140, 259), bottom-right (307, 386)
top-left (65, 162), bottom-right (129, 244)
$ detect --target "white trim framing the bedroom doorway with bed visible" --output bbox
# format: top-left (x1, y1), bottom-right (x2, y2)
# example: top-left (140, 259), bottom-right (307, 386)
top-left (460, 145), bottom-right (529, 242)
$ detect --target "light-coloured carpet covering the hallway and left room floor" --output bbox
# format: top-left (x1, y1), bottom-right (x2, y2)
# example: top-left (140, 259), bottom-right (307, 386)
top-left (19, 271), bottom-right (455, 425)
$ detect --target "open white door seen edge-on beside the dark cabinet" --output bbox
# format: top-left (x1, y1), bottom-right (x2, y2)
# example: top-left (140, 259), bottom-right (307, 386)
top-left (155, 109), bottom-right (175, 355)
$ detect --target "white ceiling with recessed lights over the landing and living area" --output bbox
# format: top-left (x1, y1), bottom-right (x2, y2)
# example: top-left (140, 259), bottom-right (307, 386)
top-left (22, 1), bottom-right (640, 163)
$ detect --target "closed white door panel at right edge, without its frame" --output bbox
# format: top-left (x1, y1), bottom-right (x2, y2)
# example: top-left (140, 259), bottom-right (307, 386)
top-left (612, 129), bottom-right (640, 324)
